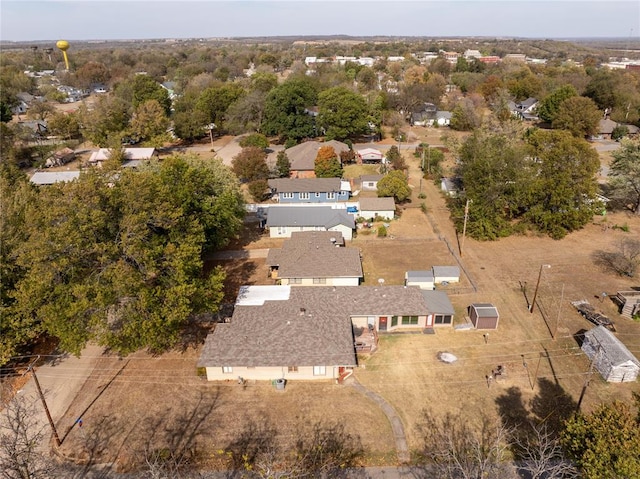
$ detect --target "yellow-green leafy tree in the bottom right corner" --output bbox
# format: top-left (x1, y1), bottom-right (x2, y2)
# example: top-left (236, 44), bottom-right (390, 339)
top-left (561, 394), bottom-right (640, 479)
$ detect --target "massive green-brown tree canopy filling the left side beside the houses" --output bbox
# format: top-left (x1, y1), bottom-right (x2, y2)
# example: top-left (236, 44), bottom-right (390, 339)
top-left (10, 157), bottom-right (243, 354)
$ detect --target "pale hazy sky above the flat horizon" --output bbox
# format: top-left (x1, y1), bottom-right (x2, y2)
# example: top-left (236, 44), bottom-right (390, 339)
top-left (0, 0), bottom-right (640, 41)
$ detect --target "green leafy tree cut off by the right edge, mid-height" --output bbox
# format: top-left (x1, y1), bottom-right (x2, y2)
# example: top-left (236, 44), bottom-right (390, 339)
top-left (609, 139), bottom-right (640, 215)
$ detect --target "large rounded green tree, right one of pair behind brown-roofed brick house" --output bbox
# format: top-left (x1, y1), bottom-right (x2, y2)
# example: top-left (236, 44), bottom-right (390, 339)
top-left (318, 87), bottom-right (370, 140)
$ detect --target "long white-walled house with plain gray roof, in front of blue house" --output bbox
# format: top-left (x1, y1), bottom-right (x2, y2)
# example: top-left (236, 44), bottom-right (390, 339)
top-left (266, 206), bottom-right (355, 240)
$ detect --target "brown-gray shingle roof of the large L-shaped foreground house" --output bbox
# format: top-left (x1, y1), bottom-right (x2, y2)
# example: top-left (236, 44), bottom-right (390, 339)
top-left (198, 286), bottom-right (427, 367)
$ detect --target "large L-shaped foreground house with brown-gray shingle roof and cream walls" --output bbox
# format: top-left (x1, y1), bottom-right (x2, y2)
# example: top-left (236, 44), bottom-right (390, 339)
top-left (198, 286), bottom-right (428, 381)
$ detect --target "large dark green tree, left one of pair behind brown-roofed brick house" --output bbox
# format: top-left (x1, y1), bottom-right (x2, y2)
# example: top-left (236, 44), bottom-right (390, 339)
top-left (262, 78), bottom-right (318, 140)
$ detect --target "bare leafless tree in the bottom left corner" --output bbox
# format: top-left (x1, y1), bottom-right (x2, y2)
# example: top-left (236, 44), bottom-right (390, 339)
top-left (0, 397), bottom-right (57, 479)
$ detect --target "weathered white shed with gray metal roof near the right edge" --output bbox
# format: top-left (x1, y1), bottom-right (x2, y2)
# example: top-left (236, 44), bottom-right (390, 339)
top-left (581, 326), bottom-right (640, 383)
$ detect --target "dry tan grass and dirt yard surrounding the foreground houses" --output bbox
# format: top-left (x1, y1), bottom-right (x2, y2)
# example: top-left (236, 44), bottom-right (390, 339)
top-left (53, 133), bottom-right (640, 470)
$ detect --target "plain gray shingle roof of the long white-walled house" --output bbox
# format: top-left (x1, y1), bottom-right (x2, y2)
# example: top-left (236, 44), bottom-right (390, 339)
top-left (267, 206), bottom-right (355, 229)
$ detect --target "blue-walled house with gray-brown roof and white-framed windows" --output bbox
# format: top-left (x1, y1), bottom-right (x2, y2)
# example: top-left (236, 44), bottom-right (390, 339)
top-left (269, 178), bottom-right (351, 203)
